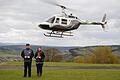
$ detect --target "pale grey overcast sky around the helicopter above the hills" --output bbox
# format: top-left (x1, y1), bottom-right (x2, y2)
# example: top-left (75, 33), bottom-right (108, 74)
top-left (0, 0), bottom-right (120, 46)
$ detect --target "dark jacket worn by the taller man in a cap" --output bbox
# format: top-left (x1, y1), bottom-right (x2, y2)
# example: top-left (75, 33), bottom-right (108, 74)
top-left (21, 48), bottom-right (34, 62)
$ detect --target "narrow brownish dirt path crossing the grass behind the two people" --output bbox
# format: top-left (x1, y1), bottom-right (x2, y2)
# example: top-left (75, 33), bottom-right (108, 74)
top-left (0, 65), bottom-right (120, 70)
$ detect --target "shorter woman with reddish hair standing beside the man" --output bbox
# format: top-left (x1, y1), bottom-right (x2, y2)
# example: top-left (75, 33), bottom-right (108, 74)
top-left (35, 48), bottom-right (45, 77)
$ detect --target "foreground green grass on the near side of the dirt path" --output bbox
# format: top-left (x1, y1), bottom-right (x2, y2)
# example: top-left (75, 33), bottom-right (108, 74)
top-left (0, 69), bottom-right (120, 80)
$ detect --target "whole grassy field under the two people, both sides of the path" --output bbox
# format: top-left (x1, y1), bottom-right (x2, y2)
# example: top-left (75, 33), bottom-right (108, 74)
top-left (0, 62), bottom-right (120, 80)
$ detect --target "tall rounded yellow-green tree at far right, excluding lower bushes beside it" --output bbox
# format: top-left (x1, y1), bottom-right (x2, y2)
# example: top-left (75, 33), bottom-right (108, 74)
top-left (90, 46), bottom-right (119, 63)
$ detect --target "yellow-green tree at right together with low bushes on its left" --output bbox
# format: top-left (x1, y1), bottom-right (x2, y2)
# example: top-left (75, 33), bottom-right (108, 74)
top-left (74, 46), bottom-right (119, 64)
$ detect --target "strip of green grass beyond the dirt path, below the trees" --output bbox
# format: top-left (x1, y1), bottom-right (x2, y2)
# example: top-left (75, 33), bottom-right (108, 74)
top-left (0, 61), bottom-right (120, 68)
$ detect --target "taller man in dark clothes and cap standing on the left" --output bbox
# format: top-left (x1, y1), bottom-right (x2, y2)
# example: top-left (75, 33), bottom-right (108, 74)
top-left (21, 44), bottom-right (34, 77)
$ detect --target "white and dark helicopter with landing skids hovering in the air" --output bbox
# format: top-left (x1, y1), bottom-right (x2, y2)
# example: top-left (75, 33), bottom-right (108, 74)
top-left (38, 0), bottom-right (107, 38)
